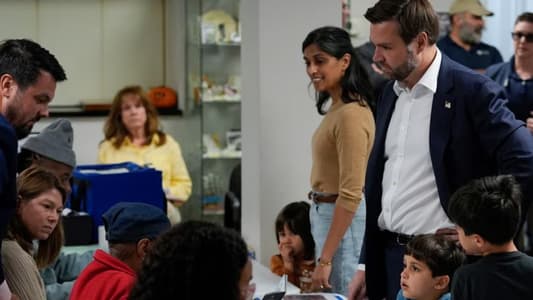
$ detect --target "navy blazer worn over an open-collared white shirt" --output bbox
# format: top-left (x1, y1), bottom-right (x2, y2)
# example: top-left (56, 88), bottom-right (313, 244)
top-left (361, 54), bottom-right (533, 299)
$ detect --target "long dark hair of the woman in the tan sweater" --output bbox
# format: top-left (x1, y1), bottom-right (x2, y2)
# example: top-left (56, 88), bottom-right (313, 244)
top-left (302, 26), bottom-right (374, 115)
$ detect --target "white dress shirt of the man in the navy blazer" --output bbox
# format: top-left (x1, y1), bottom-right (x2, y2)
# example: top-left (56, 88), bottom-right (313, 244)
top-left (378, 50), bottom-right (453, 234)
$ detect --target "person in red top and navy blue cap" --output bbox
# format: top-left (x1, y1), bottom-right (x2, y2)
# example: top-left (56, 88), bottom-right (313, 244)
top-left (70, 202), bottom-right (170, 300)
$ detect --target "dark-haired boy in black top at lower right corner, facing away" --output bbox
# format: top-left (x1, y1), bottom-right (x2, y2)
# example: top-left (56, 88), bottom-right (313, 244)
top-left (448, 175), bottom-right (533, 300)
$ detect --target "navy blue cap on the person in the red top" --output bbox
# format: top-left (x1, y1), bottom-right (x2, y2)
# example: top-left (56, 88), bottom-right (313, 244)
top-left (102, 202), bottom-right (170, 243)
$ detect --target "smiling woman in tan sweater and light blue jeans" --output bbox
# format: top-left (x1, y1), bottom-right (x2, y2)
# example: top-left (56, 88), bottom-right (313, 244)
top-left (302, 27), bottom-right (375, 295)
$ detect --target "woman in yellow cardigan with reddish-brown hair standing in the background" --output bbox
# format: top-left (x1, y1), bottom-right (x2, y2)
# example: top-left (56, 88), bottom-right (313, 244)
top-left (98, 86), bottom-right (192, 224)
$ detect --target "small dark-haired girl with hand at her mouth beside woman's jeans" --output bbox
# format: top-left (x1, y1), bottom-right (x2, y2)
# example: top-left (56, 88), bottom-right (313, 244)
top-left (270, 202), bottom-right (315, 292)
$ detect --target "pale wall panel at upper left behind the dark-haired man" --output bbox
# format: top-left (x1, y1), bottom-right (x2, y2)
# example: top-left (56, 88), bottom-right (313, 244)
top-left (0, 0), bottom-right (165, 106)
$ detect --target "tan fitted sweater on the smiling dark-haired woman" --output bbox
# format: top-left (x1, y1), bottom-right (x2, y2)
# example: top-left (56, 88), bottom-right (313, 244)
top-left (311, 102), bottom-right (375, 212)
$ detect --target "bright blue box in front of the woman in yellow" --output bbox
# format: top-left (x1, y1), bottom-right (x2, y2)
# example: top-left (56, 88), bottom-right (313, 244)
top-left (67, 162), bottom-right (166, 242)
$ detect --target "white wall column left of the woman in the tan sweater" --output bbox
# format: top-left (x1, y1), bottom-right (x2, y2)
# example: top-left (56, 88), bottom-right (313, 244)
top-left (241, 0), bottom-right (341, 264)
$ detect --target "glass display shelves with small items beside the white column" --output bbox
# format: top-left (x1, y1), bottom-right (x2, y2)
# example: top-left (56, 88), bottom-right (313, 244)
top-left (186, 0), bottom-right (239, 222)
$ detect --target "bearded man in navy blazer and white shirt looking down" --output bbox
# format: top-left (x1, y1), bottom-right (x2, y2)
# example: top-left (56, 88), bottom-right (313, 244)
top-left (349, 0), bottom-right (533, 299)
